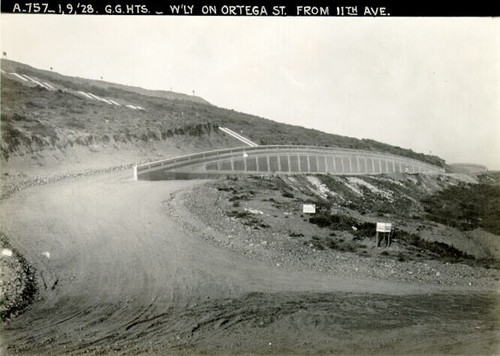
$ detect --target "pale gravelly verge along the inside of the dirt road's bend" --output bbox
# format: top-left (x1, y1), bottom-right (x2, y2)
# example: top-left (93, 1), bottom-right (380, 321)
top-left (168, 175), bottom-right (500, 290)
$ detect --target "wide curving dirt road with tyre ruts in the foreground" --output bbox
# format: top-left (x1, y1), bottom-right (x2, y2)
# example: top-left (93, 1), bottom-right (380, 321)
top-left (0, 172), bottom-right (500, 354)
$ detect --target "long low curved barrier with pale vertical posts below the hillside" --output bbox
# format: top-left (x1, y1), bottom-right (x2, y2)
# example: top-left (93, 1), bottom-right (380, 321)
top-left (134, 145), bottom-right (444, 180)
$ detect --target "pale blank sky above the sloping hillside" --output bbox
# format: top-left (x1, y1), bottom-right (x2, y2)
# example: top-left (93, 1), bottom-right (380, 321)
top-left (1, 14), bottom-right (500, 169)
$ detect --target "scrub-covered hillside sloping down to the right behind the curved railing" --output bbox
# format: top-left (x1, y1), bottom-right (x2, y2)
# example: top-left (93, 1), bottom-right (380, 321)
top-left (1, 59), bottom-right (445, 167)
